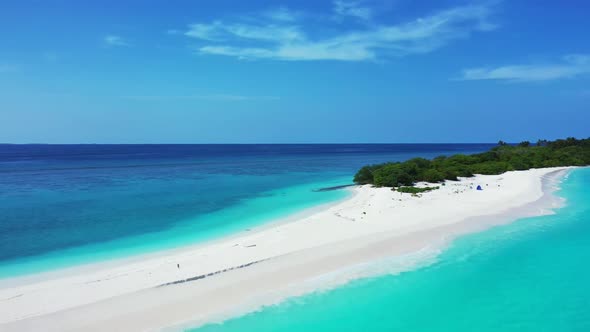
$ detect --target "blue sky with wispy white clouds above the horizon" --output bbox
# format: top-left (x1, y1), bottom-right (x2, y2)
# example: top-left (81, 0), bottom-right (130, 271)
top-left (0, 0), bottom-right (590, 143)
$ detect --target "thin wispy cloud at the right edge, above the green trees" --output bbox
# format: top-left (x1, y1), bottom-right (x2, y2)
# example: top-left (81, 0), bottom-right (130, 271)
top-left (461, 54), bottom-right (590, 82)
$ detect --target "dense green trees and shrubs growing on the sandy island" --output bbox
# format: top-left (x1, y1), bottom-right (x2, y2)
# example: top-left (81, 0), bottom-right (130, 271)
top-left (354, 137), bottom-right (590, 187)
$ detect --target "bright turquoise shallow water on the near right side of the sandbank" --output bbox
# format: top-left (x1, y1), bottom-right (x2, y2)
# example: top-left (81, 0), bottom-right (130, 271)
top-left (194, 168), bottom-right (590, 332)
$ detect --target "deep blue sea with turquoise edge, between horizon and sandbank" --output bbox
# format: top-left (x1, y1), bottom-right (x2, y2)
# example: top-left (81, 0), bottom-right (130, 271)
top-left (0, 144), bottom-right (493, 278)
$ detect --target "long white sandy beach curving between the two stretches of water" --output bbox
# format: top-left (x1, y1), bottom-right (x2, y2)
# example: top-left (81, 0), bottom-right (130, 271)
top-left (0, 168), bottom-right (568, 331)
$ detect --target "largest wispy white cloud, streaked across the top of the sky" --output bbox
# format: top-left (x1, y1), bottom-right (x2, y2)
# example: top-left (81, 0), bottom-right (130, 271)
top-left (184, 0), bottom-right (496, 61)
